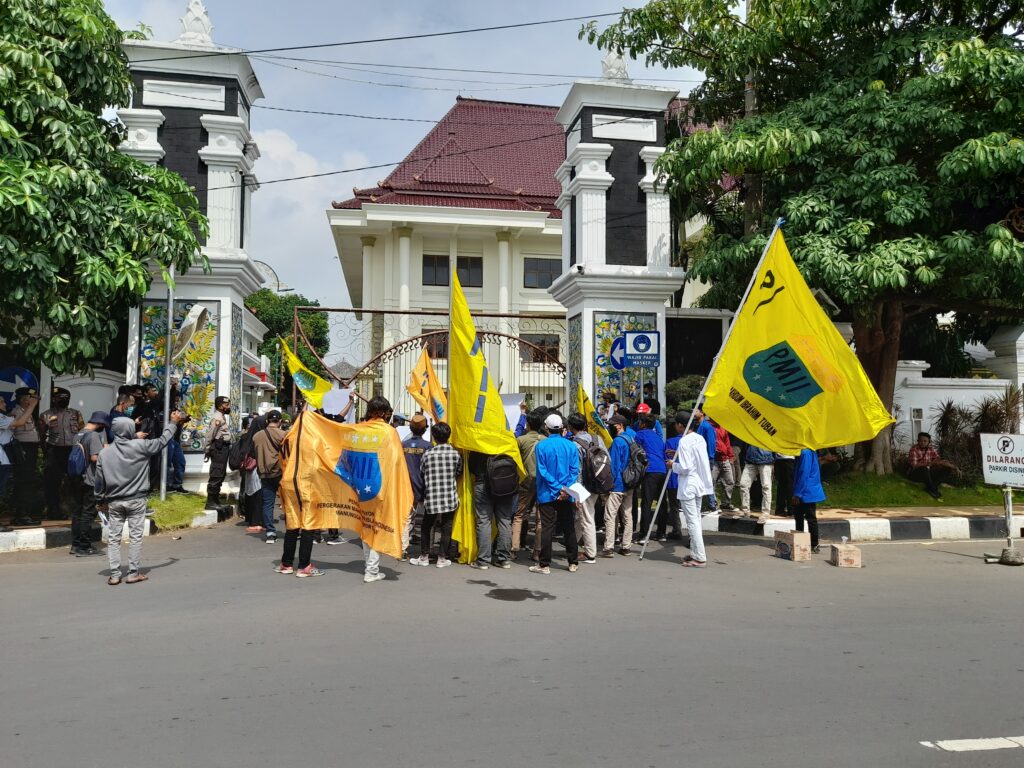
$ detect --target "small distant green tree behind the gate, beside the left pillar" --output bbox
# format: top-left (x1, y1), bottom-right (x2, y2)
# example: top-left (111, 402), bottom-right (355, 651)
top-left (246, 288), bottom-right (331, 404)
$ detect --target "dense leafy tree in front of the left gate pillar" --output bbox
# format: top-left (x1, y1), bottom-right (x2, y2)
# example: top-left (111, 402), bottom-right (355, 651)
top-left (0, 0), bottom-right (207, 373)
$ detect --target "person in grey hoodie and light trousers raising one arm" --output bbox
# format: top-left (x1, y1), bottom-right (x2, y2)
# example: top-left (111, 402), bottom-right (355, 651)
top-left (94, 411), bottom-right (185, 587)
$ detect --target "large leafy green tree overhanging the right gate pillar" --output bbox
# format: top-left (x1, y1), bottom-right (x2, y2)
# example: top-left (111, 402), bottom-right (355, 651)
top-left (581, 0), bottom-right (1024, 473)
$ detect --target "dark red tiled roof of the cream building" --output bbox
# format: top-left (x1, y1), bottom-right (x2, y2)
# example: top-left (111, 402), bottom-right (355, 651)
top-left (333, 96), bottom-right (565, 218)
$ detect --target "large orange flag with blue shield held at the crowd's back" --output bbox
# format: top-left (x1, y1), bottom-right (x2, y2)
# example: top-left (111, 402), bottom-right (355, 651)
top-left (280, 411), bottom-right (413, 558)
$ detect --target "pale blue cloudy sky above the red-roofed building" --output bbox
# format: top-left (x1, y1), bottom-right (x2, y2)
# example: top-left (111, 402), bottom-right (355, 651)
top-left (104, 0), bottom-right (699, 307)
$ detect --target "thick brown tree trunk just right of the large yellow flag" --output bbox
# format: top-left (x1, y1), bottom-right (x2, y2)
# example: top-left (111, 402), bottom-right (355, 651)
top-left (853, 299), bottom-right (903, 475)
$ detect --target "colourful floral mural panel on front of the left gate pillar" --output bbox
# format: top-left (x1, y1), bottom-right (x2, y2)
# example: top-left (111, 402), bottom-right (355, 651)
top-left (138, 301), bottom-right (220, 453)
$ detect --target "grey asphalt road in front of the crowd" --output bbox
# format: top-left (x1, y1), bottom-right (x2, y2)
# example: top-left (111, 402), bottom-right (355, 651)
top-left (0, 523), bottom-right (1024, 768)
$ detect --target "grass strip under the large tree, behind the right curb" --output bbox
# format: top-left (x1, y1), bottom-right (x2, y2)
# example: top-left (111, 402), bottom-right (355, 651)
top-left (818, 472), bottom-right (1002, 509)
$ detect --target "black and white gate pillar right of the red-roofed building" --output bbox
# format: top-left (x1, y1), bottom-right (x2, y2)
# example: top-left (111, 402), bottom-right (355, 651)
top-left (548, 55), bottom-right (685, 411)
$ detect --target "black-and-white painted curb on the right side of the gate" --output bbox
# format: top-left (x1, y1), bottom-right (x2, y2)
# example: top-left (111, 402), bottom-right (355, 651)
top-left (700, 514), bottom-right (1024, 542)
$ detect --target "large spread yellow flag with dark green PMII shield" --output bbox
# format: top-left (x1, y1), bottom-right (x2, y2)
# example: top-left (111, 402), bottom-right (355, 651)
top-left (705, 230), bottom-right (893, 454)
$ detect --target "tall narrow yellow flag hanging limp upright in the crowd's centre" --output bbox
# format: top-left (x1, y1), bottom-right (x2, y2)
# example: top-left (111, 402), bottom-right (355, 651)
top-left (447, 274), bottom-right (526, 477)
